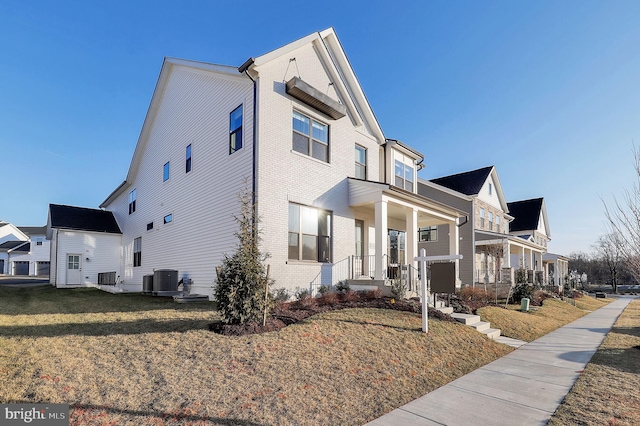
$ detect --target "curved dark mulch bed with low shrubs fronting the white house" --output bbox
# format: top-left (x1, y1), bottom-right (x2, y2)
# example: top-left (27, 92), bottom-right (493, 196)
top-left (209, 291), bottom-right (455, 336)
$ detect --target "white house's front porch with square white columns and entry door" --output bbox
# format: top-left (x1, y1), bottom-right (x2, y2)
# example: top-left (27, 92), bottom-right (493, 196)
top-left (310, 179), bottom-right (466, 295)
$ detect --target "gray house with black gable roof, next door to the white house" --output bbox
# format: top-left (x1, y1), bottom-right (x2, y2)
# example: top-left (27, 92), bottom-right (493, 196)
top-left (418, 166), bottom-right (513, 286)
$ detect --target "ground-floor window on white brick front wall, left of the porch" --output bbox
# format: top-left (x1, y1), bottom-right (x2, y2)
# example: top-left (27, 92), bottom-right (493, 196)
top-left (289, 203), bottom-right (331, 262)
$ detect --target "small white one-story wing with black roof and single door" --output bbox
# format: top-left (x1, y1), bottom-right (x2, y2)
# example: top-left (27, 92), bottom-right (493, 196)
top-left (46, 204), bottom-right (122, 287)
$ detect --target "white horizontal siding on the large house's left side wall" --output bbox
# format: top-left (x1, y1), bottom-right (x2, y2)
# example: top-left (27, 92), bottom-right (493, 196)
top-left (107, 65), bottom-right (254, 294)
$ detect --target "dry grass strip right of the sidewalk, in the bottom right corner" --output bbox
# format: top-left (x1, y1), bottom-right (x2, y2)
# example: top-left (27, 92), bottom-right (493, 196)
top-left (549, 300), bottom-right (640, 425)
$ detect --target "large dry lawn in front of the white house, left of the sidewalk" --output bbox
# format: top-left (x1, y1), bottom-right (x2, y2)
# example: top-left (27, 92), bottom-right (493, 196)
top-left (0, 289), bottom-right (512, 425)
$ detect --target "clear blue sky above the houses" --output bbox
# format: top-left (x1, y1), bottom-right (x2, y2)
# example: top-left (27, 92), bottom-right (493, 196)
top-left (0, 0), bottom-right (640, 254)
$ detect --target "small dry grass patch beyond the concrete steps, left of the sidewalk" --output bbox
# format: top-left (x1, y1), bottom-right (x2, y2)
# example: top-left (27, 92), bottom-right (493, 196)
top-left (478, 296), bottom-right (606, 342)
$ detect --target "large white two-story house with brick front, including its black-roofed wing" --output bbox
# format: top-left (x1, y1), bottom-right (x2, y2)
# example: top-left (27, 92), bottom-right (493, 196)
top-left (47, 29), bottom-right (466, 295)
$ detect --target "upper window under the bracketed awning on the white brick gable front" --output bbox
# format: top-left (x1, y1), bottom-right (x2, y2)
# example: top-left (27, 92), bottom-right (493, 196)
top-left (293, 111), bottom-right (329, 163)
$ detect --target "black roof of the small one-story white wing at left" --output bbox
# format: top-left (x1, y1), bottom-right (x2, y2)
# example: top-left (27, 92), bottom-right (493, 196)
top-left (49, 204), bottom-right (122, 234)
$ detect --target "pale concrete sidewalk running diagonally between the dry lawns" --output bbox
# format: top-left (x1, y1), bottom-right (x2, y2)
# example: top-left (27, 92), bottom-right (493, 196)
top-left (367, 298), bottom-right (633, 426)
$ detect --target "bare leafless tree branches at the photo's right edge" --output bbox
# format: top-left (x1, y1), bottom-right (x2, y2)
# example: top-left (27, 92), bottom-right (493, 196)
top-left (604, 145), bottom-right (640, 280)
